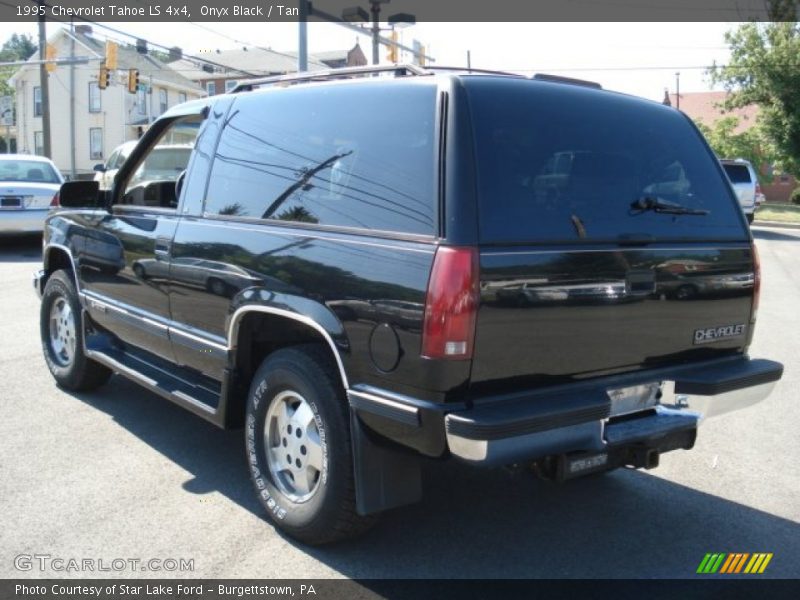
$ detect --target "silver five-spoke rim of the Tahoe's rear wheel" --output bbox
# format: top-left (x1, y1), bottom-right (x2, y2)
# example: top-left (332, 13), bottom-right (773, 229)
top-left (264, 391), bottom-right (324, 502)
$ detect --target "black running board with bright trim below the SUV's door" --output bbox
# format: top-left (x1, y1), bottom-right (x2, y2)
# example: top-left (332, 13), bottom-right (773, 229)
top-left (86, 343), bottom-right (225, 427)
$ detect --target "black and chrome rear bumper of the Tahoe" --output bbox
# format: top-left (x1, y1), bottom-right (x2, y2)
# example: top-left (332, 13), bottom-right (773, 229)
top-left (349, 357), bottom-right (783, 465)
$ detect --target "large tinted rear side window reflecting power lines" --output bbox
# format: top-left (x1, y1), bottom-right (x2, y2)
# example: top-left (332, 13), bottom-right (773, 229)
top-left (205, 82), bottom-right (436, 234)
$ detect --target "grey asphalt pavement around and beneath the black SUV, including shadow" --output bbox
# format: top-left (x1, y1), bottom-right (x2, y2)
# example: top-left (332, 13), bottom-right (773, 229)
top-left (0, 228), bottom-right (800, 578)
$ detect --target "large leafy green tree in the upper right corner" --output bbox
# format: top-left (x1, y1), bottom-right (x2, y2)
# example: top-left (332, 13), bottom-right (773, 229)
top-left (710, 22), bottom-right (800, 177)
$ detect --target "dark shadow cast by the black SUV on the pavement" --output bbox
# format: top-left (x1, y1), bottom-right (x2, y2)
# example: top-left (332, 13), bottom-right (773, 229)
top-left (70, 376), bottom-right (800, 580)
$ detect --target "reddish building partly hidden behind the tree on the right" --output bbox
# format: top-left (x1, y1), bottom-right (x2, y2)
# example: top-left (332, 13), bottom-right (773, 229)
top-left (668, 92), bottom-right (798, 202)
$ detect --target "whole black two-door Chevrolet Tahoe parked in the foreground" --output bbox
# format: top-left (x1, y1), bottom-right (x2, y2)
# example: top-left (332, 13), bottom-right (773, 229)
top-left (34, 66), bottom-right (783, 543)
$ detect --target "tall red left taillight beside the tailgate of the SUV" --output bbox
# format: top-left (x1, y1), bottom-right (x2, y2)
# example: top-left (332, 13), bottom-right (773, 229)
top-left (422, 246), bottom-right (479, 359)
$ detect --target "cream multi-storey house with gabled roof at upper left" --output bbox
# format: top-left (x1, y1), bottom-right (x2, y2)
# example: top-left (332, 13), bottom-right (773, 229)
top-left (9, 25), bottom-right (205, 178)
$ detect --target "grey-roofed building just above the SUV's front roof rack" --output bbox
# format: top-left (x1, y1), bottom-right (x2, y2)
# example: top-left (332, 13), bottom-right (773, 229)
top-left (169, 43), bottom-right (367, 96)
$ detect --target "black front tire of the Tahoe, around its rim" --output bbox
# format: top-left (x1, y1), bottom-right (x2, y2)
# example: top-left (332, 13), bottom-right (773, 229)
top-left (39, 270), bottom-right (111, 392)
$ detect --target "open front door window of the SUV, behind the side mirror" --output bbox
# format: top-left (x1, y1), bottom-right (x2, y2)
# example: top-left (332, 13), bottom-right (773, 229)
top-left (120, 115), bottom-right (202, 208)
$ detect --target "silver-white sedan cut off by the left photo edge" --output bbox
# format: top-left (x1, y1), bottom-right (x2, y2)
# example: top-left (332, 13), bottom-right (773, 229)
top-left (0, 154), bottom-right (64, 234)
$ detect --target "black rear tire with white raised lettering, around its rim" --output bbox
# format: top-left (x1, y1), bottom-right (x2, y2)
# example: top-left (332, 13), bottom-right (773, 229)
top-left (245, 344), bottom-right (376, 545)
